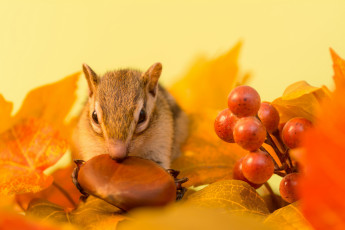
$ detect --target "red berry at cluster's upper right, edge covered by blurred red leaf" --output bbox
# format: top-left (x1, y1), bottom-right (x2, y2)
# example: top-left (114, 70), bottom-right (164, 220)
top-left (282, 117), bottom-right (312, 149)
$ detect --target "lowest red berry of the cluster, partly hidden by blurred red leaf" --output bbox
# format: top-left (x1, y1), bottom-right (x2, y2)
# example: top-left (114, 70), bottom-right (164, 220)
top-left (279, 173), bottom-right (300, 203)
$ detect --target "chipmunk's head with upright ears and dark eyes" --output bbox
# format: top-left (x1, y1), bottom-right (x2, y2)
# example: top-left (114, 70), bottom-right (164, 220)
top-left (83, 63), bottom-right (162, 160)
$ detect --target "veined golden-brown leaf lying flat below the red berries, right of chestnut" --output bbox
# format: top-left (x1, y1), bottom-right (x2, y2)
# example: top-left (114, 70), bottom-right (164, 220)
top-left (186, 180), bottom-right (269, 218)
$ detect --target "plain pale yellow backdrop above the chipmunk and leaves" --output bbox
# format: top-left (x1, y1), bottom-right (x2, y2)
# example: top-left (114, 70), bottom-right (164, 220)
top-left (0, 0), bottom-right (345, 112)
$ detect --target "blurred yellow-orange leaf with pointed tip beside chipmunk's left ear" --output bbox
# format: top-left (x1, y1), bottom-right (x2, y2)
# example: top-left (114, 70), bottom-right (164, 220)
top-left (0, 72), bottom-right (80, 137)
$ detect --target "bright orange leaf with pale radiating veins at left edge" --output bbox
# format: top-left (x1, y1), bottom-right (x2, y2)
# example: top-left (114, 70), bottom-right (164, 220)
top-left (0, 119), bottom-right (67, 195)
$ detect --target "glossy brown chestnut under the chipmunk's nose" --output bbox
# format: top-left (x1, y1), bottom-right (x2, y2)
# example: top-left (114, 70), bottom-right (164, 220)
top-left (78, 154), bottom-right (176, 211)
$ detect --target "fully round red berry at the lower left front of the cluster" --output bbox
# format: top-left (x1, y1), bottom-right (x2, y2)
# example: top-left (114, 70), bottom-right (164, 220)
top-left (242, 150), bottom-right (274, 184)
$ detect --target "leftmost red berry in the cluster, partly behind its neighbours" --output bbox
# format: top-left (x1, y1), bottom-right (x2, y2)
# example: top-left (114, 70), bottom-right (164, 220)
top-left (214, 109), bottom-right (238, 143)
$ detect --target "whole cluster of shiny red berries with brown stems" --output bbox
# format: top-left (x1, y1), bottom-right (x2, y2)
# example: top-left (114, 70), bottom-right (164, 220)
top-left (214, 86), bottom-right (312, 203)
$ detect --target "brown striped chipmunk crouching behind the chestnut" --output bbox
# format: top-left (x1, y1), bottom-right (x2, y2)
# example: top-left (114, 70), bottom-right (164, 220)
top-left (73, 63), bottom-right (188, 168)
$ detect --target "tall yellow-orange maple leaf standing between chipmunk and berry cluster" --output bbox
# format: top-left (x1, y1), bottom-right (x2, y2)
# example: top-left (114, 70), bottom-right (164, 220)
top-left (170, 43), bottom-right (248, 187)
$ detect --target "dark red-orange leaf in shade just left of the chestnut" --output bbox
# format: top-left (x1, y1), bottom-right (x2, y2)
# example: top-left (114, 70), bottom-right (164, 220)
top-left (16, 165), bottom-right (81, 210)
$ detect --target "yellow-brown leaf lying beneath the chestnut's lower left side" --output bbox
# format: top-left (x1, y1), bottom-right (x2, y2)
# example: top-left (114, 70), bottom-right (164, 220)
top-left (26, 196), bottom-right (126, 230)
